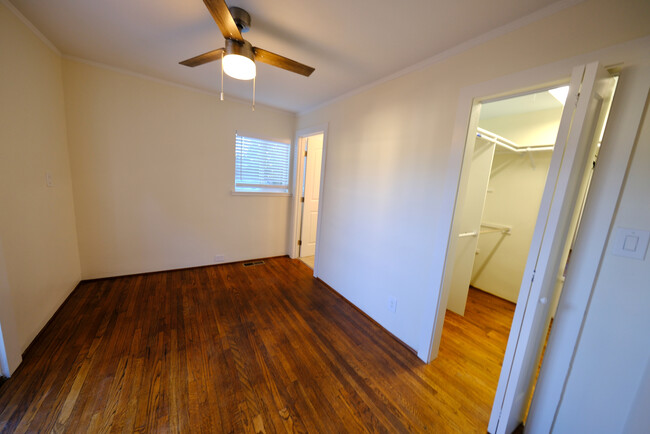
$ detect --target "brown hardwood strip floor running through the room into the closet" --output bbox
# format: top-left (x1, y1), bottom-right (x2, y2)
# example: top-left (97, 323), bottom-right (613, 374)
top-left (0, 257), bottom-right (514, 433)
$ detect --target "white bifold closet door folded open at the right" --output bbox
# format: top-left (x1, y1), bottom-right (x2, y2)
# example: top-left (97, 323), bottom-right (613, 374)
top-left (488, 63), bottom-right (614, 434)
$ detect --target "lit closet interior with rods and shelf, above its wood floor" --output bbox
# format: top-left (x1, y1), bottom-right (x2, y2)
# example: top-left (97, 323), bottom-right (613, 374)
top-left (447, 87), bottom-right (567, 315)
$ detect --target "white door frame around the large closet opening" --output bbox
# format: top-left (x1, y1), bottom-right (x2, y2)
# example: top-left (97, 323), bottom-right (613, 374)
top-left (418, 56), bottom-right (644, 428)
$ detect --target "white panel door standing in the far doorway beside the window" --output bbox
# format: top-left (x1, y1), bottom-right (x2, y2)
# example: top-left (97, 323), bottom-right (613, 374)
top-left (300, 134), bottom-right (323, 257)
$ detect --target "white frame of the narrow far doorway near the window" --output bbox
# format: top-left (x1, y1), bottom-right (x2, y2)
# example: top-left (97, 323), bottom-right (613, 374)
top-left (289, 124), bottom-right (329, 277)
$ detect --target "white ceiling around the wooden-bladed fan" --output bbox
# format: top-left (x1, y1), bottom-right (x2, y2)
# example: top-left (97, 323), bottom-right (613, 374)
top-left (10, 0), bottom-right (566, 112)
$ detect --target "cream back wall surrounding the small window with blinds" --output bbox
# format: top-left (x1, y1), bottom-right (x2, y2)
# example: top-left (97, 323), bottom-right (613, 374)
top-left (64, 60), bottom-right (295, 279)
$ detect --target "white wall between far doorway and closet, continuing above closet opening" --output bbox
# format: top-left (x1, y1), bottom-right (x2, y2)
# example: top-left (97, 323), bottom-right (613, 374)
top-left (298, 0), bottom-right (650, 349)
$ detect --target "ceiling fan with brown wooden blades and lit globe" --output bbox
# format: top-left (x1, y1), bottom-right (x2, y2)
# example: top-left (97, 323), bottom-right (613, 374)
top-left (179, 0), bottom-right (314, 80)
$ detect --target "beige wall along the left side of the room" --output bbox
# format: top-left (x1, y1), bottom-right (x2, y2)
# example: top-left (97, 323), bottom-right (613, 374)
top-left (0, 5), bottom-right (81, 352)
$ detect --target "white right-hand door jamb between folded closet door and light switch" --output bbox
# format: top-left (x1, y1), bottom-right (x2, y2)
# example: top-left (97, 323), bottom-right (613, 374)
top-left (526, 65), bottom-right (650, 432)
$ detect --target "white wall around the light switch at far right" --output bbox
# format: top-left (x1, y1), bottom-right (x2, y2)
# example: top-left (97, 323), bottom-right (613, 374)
top-left (555, 72), bottom-right (650, 433)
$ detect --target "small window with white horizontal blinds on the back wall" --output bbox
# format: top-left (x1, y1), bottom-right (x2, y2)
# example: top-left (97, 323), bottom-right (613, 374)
top-left (235, 134), bottom-right (291, 193)
